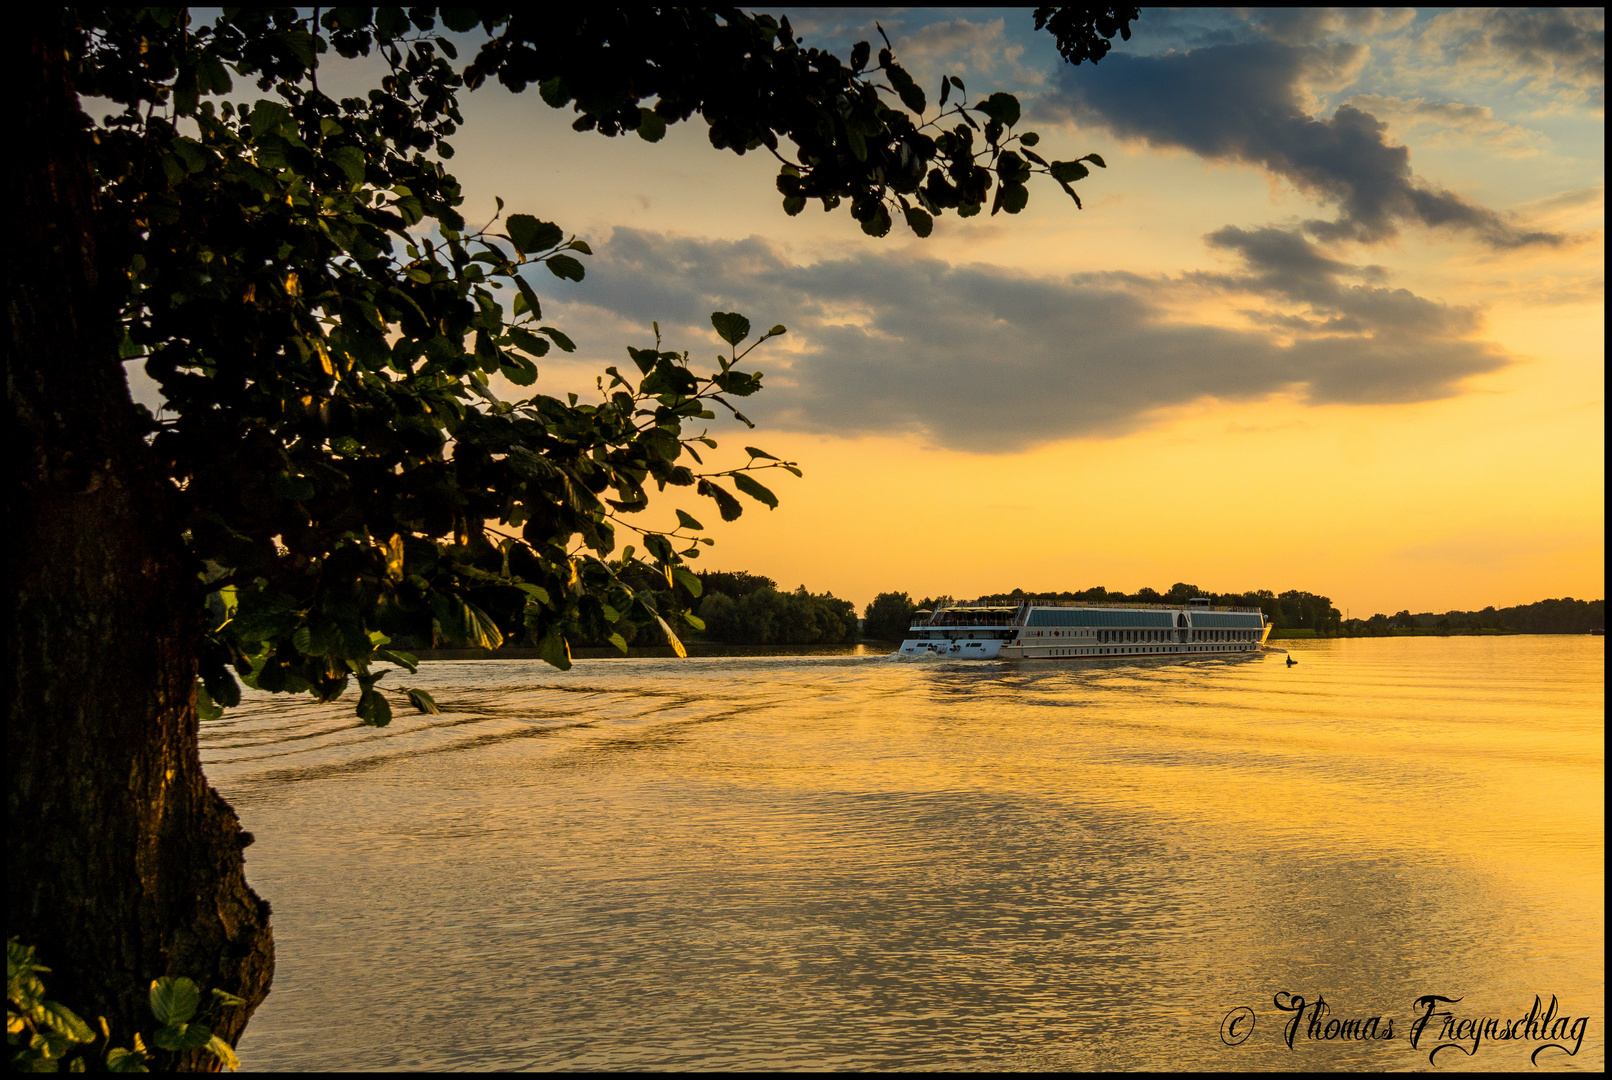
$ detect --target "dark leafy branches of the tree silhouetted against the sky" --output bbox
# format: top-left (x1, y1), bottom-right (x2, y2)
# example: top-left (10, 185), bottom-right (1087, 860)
top-left (68, 6), bottom-right (1135, 724)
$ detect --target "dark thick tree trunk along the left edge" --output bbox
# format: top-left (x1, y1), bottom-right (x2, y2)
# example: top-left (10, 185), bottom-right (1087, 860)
top-left (5, 16), bottom-right (274, 1069)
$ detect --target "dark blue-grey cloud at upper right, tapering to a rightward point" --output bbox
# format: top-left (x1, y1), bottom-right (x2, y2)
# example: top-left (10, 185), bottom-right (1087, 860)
top-left (1040, 40), bottom-right (1562, 248)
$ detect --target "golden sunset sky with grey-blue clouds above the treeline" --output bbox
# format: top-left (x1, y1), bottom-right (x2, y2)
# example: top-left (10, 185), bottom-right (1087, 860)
top-left (141, 8), bottom-right (1606, 617)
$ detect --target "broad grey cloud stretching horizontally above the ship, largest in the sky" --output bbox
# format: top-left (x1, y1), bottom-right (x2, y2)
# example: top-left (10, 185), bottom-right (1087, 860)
top-left (557, 229), bottom-right (1506, 453)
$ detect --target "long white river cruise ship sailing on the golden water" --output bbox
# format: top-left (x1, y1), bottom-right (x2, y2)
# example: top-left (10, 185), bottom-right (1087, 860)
top-left (901, 596), bottom-right (1270, 659)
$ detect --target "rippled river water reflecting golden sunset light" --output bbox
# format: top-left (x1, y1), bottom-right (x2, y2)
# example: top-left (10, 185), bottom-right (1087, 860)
top-left (202, 637), bottom-right (1606, 1070)
